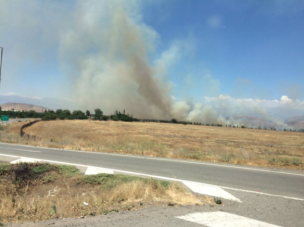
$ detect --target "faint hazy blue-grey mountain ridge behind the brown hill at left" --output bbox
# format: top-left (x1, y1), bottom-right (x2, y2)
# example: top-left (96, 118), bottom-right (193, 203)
top-left (0, 95), bottom-right (77, 110)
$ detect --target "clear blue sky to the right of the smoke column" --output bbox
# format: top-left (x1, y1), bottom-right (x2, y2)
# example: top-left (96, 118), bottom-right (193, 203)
top-left (143, 0), bottom-right (304, 99)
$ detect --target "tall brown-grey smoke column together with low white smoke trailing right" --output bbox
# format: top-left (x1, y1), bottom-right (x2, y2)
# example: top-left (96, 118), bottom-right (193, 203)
top-left (55, 1), bottom-right (294, 128)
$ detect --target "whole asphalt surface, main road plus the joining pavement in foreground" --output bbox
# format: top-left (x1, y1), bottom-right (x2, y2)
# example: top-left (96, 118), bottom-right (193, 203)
top-left (0, 143), bottom-right (304, 227)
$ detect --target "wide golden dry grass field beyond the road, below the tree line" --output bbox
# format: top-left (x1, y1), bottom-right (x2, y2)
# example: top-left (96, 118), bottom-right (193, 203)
top-left (0, 120), bottom-right (304, 169)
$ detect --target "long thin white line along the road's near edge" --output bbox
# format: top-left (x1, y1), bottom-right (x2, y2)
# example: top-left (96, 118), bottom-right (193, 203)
top-left (0, 154), bottom-right (304, 201)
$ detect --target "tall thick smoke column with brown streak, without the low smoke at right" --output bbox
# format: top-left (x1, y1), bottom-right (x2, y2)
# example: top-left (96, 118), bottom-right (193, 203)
top-left (60, 1), bottom-right (171, 118)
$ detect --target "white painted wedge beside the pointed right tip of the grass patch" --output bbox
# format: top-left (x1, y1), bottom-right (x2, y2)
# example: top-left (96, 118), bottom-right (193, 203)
top-left (183, 181), bottom-right (242, 203)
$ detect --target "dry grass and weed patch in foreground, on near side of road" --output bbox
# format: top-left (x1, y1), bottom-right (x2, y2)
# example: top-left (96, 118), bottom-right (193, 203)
top-left (0, 163), bottom-right (209, 223)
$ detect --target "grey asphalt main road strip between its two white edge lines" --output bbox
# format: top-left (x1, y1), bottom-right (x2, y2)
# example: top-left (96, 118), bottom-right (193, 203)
top-left (0, 143), bottom-right (304, 199)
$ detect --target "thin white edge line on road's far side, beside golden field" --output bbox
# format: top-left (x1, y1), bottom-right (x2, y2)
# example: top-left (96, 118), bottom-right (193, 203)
top-left (0, 142), bottom-right (304, 177)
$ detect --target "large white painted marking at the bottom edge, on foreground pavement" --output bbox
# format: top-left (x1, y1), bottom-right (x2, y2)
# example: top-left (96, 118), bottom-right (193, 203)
top-left (176, 211), bottom-right (280, 227)
